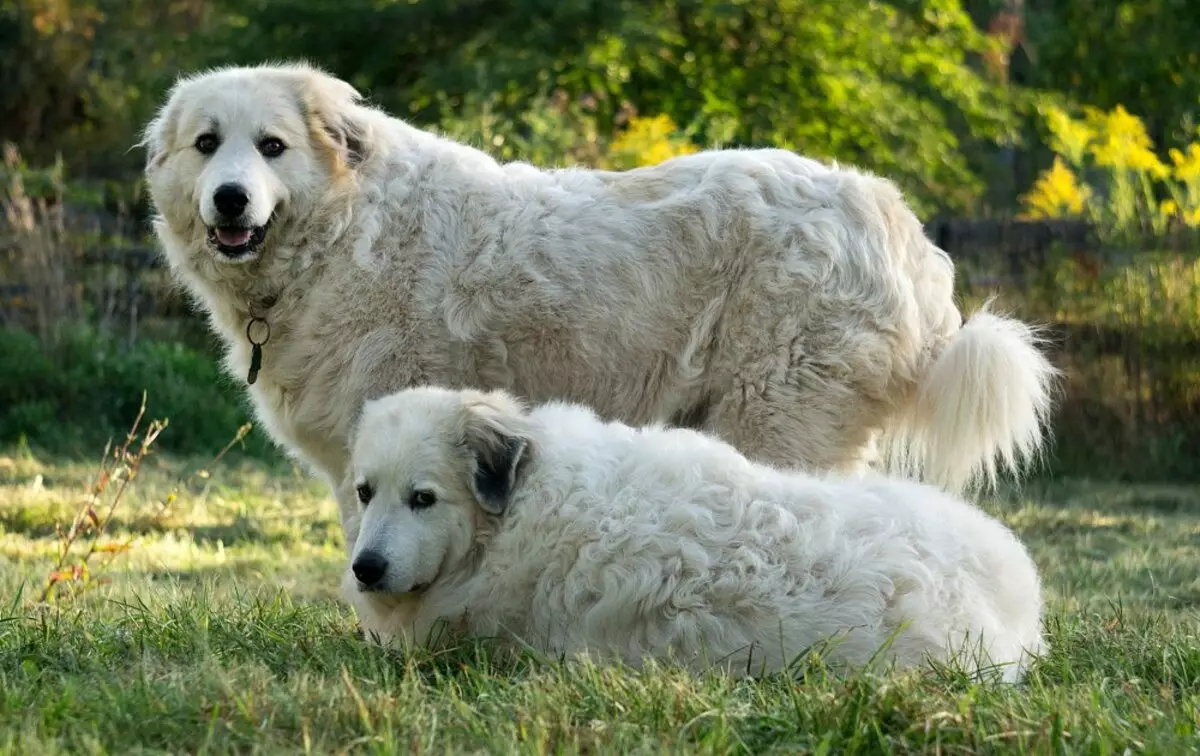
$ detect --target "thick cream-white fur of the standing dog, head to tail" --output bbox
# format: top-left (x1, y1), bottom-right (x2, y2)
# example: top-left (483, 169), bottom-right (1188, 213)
top-left (144, 65), bottom-right (1052, 544)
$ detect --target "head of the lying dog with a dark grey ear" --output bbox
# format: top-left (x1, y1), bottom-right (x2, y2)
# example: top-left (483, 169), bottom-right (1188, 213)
top-left (347, 386), bottom-right (530, 596)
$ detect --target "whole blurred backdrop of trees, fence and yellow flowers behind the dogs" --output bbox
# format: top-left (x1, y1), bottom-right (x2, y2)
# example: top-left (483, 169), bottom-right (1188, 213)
top-left (0, 0), bottom-right (1200, 481)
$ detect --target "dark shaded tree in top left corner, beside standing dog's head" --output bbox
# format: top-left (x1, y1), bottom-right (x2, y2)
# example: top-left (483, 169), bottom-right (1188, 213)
top-left (0, 0), bottom-right (224, 179)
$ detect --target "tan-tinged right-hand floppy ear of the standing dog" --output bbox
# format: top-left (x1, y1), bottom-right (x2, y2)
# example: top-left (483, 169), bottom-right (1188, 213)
top-left (292, 68), bottom-right (370, 173)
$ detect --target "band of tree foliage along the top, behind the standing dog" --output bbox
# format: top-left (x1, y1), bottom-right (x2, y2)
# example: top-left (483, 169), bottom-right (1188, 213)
top-left (0, 0), bottom-right (1200, 215)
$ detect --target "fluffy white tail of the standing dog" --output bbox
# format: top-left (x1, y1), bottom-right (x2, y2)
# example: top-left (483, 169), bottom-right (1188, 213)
top-left (881, 305), bottom-right (1058, 493)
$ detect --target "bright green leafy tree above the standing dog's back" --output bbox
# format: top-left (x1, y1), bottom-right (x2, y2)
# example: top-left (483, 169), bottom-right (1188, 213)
top-left (228, 0), bottom-right (1016, 219)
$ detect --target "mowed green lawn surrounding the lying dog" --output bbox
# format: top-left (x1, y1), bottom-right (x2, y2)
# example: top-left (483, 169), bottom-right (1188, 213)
top-left (0, 452), bottom-right (1200, 754)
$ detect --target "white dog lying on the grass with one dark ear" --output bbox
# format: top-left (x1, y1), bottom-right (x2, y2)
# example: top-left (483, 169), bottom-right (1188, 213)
top-left (343, 388), bottom-right (1045, 680)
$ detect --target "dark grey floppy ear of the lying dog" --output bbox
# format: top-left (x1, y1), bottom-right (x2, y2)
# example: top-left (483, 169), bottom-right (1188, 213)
top-left (462, 391), bottom-right (529, 515)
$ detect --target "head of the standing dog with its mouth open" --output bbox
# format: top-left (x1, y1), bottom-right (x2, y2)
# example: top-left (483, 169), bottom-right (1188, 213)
top-left (142, 65), bottom-right (368, 270)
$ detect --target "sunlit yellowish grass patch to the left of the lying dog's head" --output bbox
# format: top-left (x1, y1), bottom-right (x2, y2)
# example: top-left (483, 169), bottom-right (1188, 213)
top-left (0, 455), bottom-right (342, 609)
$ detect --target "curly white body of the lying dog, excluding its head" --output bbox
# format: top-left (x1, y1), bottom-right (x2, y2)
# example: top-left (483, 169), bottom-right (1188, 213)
top-left (476, 404), bottom-right (1043, 679)
